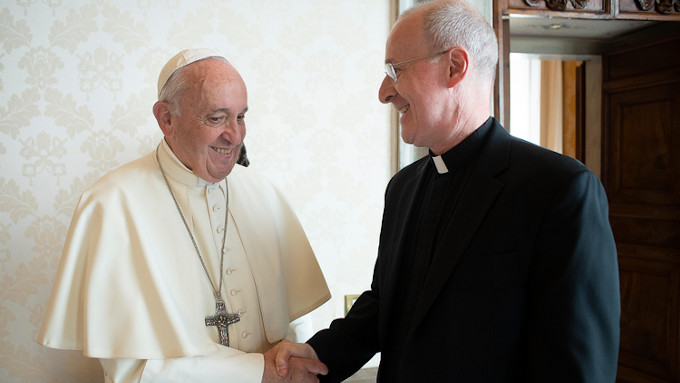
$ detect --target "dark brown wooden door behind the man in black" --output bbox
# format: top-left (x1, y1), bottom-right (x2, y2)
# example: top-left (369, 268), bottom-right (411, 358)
top-left (602, 25), bottom-right (680, 382)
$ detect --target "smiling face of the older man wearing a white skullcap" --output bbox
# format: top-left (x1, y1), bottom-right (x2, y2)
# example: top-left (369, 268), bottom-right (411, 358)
top-left (154, 58), bottom-right (248, 182)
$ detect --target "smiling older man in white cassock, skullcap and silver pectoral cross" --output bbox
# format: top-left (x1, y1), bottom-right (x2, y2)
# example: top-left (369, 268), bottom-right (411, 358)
top-left (38, 49), bottom-right (330, 382)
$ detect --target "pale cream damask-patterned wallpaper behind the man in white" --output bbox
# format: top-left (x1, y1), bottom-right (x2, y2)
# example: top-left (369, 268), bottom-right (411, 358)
top-left (0, 0), bottom-right (390, 383)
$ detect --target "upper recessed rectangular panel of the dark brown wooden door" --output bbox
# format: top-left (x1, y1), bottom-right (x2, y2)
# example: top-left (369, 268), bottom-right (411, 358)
top-left (608, 79), bottom-right (680, 208)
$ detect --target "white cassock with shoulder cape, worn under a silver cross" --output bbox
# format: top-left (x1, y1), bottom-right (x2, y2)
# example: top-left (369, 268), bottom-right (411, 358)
top-left (38, 140), bottom-right (330, 382)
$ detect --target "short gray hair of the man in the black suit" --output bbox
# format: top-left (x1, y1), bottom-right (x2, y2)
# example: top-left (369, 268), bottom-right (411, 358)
top-left (409, 0), bottom-right (498, 84)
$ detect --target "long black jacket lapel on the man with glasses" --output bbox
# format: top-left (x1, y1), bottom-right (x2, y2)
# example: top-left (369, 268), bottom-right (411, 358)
top-left (411, 121), bottom-right (510, 329)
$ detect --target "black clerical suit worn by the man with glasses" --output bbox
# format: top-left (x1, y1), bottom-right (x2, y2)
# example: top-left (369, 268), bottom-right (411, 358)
top-left (308, 118), bottom-right (620, 383)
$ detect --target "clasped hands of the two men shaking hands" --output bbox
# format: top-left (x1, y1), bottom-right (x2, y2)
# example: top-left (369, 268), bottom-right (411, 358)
top-left (262, 340), bottom-right (328, 383)
